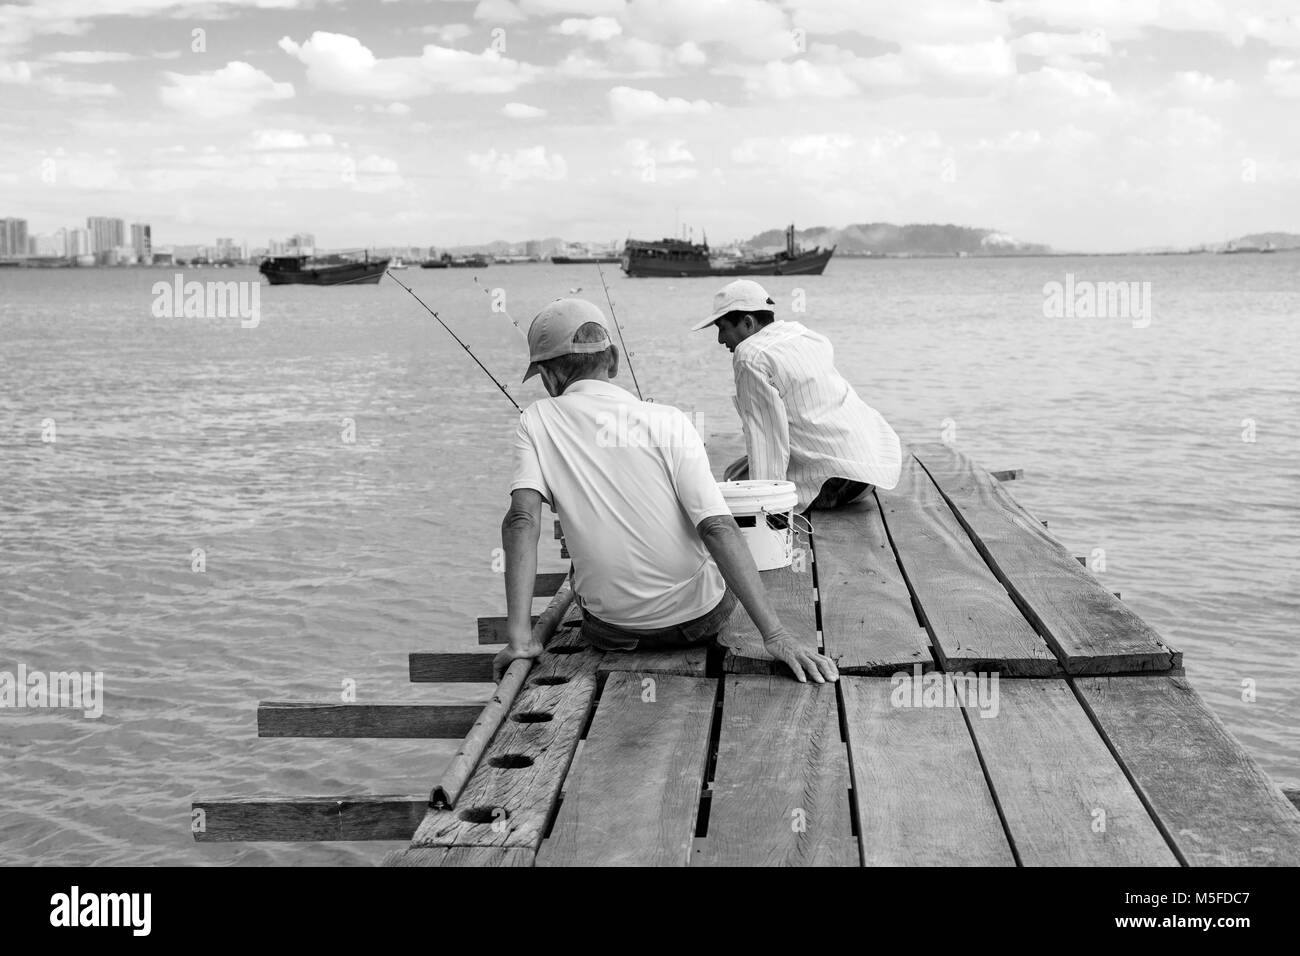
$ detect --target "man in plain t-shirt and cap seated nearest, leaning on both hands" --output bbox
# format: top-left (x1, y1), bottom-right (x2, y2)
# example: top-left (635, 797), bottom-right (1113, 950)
top-left (494, 299), bottom-right (839, 683)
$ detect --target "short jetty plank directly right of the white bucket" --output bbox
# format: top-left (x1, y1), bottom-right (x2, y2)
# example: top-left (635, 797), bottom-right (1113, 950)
top-left (813, 496), bottom-right (933, 676)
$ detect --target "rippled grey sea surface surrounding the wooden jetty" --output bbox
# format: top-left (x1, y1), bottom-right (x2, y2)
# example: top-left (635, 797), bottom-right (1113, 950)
top-left (0, 254), bottom-right (1300, 864)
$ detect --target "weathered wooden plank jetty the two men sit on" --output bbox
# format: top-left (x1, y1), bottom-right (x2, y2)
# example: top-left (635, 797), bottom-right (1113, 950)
top-left (194, 444), bottom-right (1300, 866)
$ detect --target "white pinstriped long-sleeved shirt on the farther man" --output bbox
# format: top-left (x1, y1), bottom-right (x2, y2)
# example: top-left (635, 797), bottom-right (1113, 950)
top-left (732, 321), bottom-right (902, 509)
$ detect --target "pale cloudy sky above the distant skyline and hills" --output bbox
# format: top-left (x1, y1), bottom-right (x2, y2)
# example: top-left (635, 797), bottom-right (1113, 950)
top-left (0, 0), bottom-right (1300, 251)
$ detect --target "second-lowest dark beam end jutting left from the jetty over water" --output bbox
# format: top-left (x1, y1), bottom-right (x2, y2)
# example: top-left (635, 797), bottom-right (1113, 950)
top-left (257, 701), bottom-right (482, 739)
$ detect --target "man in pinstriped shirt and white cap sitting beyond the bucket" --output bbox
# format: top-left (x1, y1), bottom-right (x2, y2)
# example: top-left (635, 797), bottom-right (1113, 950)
top-left (692, 278), bottom-right (902, 511)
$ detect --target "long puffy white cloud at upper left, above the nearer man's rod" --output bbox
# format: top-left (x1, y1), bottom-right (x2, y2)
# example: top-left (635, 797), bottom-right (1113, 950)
top-left (280, 31), bottom-right (540, 99)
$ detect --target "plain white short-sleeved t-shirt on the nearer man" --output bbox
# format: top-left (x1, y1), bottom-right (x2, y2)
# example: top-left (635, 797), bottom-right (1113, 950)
top-left (510, 378), bottom-right (731, 628)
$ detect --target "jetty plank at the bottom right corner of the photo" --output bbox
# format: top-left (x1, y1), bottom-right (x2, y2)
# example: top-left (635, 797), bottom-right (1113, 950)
top-left (1075, 674), bottom-right (1300, 866)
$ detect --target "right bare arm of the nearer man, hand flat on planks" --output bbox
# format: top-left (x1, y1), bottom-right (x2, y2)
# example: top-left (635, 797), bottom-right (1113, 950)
top-left (696, 515), bottom-right (840, 684)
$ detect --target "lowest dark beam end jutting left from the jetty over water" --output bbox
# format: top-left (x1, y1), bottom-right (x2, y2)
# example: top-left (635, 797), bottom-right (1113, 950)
top-left (190, 795), bottom-right (429, 843)
